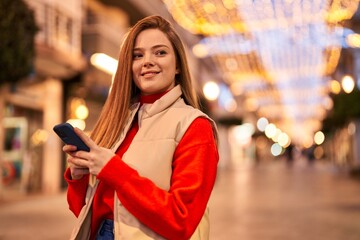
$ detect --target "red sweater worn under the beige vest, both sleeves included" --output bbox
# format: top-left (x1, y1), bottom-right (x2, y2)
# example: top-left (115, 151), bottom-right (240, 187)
top-left (65, 91), bottom-right (218, 239)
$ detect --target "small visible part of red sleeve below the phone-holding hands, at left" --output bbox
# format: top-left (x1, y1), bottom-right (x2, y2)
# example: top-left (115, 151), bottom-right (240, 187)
top-left (64, 168), bottom-right (89, 217)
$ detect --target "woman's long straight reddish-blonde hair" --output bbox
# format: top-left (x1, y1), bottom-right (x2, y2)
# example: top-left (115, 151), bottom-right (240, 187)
top-left (91, 16), bottom-right (199, 148)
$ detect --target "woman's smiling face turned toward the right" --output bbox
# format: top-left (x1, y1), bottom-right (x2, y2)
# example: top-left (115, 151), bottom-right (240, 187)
top-left (132, 29), bottom-right (178, 95)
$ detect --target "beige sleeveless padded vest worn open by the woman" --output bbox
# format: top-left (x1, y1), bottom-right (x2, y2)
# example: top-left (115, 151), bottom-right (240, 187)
top-left (71, 86), bottom-right (216, 240)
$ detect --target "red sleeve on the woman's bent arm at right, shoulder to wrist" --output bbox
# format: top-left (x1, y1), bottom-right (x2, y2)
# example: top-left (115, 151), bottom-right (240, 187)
top-left (98, 118), bottom-right (219, 239)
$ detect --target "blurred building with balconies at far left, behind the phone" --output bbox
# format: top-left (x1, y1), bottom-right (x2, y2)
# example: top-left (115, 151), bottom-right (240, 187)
top-left (0, 0), bottom-right (86, 196)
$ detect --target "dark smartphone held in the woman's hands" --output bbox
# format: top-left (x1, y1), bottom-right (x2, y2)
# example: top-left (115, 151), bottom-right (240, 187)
top-left (53, 123), bottom-right (90, 152)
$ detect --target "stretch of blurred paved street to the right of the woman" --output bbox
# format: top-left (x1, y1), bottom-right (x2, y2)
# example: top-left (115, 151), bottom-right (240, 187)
top-left (211, 159), bottom-right (360, 240)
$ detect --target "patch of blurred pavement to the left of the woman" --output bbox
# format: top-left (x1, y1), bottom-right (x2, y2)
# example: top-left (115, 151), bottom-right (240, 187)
top-left (0, 190), bottom-right (75, 240)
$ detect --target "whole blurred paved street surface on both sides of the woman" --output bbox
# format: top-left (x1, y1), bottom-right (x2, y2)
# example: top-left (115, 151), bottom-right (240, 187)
top-left (0, 158), bottom-right (360, 240)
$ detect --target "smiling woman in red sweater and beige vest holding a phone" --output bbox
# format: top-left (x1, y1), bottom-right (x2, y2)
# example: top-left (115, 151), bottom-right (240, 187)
top-left (63, 16), bottom-right (218, 239)
